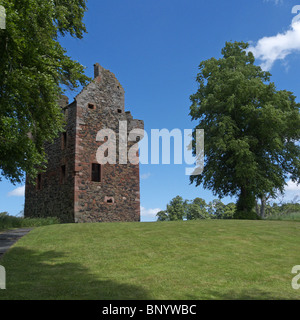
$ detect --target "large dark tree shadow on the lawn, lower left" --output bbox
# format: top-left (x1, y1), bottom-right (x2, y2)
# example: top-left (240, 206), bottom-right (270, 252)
top-left (0, 248), bottom-right (151, 300)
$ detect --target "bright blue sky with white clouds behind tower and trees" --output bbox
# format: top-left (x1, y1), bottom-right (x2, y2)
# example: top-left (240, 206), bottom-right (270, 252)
top-left (0, 0), bottom-right (300, 221)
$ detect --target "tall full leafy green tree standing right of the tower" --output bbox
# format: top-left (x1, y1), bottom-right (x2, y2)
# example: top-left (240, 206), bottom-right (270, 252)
top-left (190, 42), bottom-right (300, 219)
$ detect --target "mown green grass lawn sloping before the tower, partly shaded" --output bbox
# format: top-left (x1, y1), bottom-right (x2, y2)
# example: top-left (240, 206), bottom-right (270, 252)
top-left (0, 220), bottom-right (300, 300)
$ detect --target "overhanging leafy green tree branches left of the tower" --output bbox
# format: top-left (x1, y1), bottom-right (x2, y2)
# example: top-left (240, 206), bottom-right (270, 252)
top-left (0, 0), bottom-right (89, 183)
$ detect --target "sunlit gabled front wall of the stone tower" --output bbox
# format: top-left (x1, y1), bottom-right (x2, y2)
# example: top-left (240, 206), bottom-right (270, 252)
top-left (75, 65), bottom-right (143, 222)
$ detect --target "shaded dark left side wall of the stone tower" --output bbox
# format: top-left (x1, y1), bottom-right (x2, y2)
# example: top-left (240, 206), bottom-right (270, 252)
top-left (24, 102), bottom-right (76, 222)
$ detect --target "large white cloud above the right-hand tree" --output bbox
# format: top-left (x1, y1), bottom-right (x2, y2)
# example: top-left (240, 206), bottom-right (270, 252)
top-left (248, 15), bottom-right (300, 70)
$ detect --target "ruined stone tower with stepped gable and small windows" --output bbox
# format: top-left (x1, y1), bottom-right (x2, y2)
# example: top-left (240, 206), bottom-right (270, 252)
top-left (24, 64), bottom-right (144, 222)
